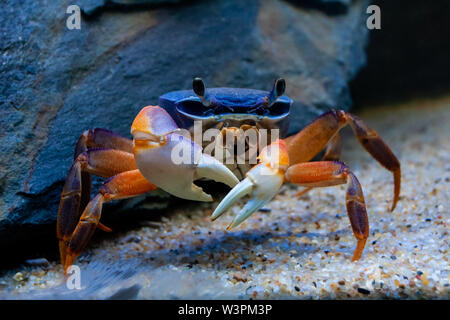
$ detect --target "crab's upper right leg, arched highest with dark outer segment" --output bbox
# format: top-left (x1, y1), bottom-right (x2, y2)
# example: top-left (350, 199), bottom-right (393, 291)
top-left (284, 110), bottom-right (401, 211)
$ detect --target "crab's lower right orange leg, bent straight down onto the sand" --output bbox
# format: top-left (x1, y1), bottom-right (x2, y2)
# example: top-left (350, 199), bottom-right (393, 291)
top-left (285, 161), bottom-right (369, 261)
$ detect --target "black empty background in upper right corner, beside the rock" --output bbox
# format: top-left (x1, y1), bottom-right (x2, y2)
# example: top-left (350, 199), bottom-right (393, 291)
top-left (350, 0), bottom-right (450, 108)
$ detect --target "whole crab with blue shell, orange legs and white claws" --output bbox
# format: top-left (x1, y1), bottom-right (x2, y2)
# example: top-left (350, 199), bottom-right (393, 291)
top-left (57, 78), bottom-right (401, 272)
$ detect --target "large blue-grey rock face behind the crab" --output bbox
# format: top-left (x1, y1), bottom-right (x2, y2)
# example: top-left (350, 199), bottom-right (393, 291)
top-left (0, 0), bottom-right (367, 249)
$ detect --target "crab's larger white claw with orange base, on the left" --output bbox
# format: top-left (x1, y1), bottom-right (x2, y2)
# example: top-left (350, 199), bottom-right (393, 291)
top-left (131, 106), bottom-right (239, 201)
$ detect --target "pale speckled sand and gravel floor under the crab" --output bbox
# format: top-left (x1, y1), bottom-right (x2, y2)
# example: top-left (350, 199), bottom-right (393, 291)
top-left (0, 97), bottom-right (450, 299)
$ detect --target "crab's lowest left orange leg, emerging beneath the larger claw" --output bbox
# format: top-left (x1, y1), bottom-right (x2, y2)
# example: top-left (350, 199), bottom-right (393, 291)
top-left (60, 169), bottom-right (156, 271)
